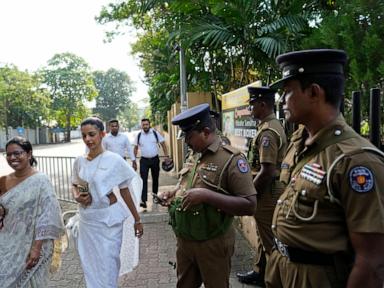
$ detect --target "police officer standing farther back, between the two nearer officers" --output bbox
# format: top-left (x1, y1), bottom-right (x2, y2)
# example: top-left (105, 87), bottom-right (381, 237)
top-left (236, 87), bottom-right (287, 286)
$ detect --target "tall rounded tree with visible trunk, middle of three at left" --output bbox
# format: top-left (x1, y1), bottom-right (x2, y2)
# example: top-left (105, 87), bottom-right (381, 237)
top-left (41, 53), bottom-right (97, 142)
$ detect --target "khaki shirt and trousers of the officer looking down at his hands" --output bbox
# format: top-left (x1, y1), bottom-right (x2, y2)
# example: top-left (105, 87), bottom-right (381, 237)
top-left (176, 137), bottom-right (256, 288)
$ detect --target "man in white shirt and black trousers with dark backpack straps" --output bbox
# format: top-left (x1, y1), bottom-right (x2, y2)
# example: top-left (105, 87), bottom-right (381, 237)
top-left (134, 118), bottom-right (169, 208)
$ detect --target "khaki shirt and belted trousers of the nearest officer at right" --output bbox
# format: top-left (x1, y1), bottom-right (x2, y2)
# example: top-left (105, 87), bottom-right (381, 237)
top-left (265, 115), bottom-right (384, 288)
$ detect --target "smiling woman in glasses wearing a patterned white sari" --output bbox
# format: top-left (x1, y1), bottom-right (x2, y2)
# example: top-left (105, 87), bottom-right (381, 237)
top-left (0, 137), bottom-right (64, 288)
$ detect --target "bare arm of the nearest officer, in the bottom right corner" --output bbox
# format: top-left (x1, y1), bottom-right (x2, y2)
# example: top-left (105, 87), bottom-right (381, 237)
top-left (347, 232), bottom-right (384, 288)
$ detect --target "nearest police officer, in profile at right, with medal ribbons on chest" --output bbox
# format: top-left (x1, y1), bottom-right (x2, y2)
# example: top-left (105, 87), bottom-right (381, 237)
top-left (266, 49), bottom-right (384, 287)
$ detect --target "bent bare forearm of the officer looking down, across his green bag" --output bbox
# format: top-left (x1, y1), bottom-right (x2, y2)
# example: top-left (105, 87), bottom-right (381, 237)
top-left (182, 188), bottom-right (256, 216)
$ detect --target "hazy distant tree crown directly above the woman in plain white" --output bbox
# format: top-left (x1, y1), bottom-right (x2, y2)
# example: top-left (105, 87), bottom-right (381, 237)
top-left (93, 68), bottom-right (134, 121)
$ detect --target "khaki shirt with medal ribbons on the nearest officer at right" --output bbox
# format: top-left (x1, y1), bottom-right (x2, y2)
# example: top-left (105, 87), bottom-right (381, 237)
top-left (272, 115), bottom-right (384, 253)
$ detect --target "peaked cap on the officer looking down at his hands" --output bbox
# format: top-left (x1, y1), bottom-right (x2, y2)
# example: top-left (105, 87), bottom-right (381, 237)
top-left (172, 103), bottom-right (211, 133)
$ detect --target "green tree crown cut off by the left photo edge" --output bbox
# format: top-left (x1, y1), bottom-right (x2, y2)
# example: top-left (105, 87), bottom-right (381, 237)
top-left (0, 66), bottom-right (51, 128)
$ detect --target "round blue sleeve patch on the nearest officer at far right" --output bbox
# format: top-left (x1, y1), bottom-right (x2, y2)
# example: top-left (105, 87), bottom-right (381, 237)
top-left (348, 166), bottom-right (375, 193)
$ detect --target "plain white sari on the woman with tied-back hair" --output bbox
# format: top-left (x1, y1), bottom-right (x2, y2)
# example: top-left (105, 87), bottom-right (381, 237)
top-left (72, 151), bottom-right (138, 288)
